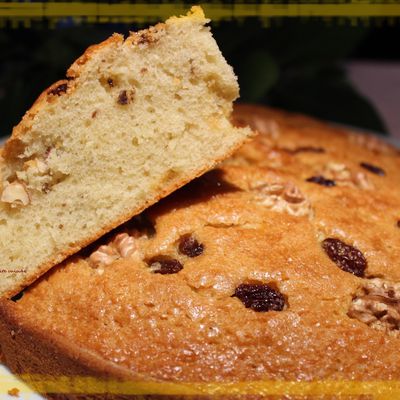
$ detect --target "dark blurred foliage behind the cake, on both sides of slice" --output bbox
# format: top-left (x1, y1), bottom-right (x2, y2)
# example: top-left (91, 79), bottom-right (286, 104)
top-left (0, 19), bottom-right (385, 135)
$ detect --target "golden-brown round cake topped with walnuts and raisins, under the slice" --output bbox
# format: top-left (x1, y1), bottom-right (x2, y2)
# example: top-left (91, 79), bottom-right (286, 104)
top-left (0, 106), bottom-right (400, 399)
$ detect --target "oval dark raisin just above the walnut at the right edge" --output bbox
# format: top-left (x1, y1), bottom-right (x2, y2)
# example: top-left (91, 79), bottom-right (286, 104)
top-left (322, 238), bottom-right (367, 277)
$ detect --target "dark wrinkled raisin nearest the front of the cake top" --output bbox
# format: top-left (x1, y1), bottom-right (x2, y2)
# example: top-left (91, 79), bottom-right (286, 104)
top-left (232, 283), bottom-right (285, 312)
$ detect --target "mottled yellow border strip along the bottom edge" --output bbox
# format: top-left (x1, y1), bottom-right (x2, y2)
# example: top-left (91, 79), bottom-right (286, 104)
top-left (0, 374), bottom-right (400, 400)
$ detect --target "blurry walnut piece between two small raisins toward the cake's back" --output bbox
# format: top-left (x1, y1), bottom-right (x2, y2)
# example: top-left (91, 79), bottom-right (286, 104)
top-left (322, 162), bottom-right (372, 189)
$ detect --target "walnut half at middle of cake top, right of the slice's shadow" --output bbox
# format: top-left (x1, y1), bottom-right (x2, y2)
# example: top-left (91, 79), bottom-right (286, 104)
top-left (251, 182), bottom-right (312, 217)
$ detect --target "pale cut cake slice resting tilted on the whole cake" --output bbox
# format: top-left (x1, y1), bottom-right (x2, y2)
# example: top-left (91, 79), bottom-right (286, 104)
top-left (0, 7), bottom-right (251, 296)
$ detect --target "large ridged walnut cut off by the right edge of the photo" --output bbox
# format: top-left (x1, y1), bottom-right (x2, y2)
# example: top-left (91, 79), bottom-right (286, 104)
top-left (347, 278), bottom-right (400, 336)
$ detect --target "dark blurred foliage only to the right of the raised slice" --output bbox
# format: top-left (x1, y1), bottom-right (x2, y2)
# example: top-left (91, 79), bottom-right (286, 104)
top-left (216, 19), bottom-right (385, 132)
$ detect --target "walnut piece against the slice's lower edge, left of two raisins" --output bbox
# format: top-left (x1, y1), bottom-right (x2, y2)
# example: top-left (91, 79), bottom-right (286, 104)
top-left (89, 233), bottom-right (137, 267)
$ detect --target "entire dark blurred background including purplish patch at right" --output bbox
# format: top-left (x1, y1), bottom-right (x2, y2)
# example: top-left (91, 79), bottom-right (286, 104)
top-left (0, 2), bottom-right (400, 137)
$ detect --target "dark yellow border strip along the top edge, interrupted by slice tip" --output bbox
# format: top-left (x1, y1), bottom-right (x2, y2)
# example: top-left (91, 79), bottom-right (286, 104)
top-left (0, 0), bottom-right (400, 21)
